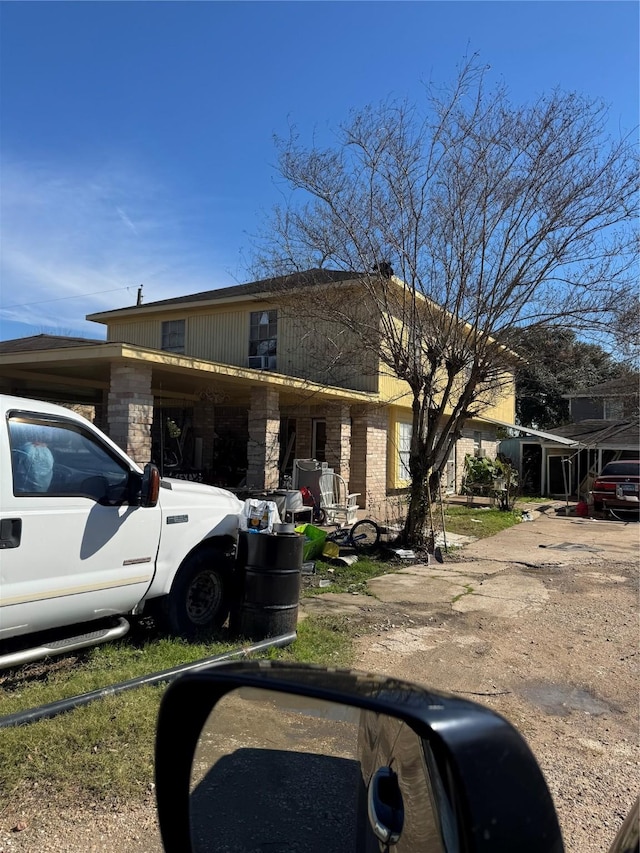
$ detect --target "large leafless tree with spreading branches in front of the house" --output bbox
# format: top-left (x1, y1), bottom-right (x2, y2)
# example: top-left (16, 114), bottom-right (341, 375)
top-left (257, 59), bottom-right (638, 546)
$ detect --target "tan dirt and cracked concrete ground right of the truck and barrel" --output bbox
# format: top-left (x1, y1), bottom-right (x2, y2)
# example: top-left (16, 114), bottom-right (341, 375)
top-left (0, 507), bottom-right (640, 853)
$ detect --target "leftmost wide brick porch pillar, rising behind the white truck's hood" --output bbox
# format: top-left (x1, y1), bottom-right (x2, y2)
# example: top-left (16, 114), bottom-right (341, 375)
top-left (107, 364), bottom-right (153, 465)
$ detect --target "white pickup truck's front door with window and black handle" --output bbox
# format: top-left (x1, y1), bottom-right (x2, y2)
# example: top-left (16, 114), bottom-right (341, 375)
top-left (0, 411), bottom-right (161, 639)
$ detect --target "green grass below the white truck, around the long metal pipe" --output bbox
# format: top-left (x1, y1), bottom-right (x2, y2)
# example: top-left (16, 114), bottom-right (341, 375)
top-left (0, 617), bottom-right (351, 808)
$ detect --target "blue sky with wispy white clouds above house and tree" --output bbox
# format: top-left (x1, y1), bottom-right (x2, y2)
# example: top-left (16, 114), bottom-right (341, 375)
top-left (0, 0), bottom-right (640, 340)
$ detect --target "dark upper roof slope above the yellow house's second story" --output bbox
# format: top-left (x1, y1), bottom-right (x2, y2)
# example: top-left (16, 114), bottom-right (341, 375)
top-left (87, 268), bottom-right (365, 323)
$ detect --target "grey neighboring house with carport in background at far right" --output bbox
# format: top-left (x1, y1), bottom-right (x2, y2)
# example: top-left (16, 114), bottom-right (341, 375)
top-left (500, 378), bottom-right (640, 498)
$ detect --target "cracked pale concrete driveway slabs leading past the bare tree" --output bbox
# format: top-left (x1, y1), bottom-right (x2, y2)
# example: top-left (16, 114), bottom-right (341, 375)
top-left (301, 507), bottom-right (640, 616)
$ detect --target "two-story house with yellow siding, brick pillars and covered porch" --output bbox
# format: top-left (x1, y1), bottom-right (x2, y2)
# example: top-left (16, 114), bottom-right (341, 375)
top-left (0, 270), bottom-right (515, 518)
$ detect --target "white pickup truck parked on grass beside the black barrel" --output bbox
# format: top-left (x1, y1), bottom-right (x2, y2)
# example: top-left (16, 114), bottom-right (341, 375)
top-left (0, 395), bottom-right (243, 668)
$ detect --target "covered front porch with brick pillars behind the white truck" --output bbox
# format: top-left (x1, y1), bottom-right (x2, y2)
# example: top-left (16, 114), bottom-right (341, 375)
top-left (0, 335), bottom-right (386, 506)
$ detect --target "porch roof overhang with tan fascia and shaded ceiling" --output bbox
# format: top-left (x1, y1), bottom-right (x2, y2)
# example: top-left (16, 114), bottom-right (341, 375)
top-left (0, 343), bottom-right (377, 406)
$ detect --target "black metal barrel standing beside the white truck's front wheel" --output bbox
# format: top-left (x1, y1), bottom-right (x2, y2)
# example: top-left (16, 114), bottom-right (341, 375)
top-left (231, 530), bottom-right (304, 640)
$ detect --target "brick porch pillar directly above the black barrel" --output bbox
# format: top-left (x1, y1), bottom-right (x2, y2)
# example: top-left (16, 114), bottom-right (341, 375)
top-left (247, 388), bottom-right (280, 489)
